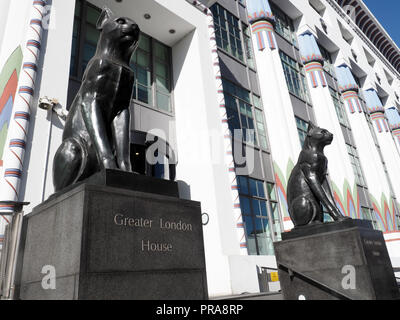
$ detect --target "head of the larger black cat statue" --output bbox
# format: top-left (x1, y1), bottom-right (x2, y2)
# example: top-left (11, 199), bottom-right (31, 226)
top-left (96, 7), bottom-right (140, 51)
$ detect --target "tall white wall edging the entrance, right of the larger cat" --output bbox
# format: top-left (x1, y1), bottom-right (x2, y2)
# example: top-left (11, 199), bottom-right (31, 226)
top-left (173, 28), bottom-right (234, 296)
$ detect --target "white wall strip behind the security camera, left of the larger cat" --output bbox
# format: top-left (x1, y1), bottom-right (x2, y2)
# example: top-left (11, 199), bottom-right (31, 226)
top-left (21, 0), bottom-right (75, 213)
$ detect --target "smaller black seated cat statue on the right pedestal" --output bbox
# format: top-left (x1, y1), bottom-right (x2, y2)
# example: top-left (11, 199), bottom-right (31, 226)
top-left (287, 123), bottom-right (348, 227)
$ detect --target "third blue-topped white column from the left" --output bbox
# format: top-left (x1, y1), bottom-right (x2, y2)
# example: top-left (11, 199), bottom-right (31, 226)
top-left (336, 64), bottom-right (393, 230)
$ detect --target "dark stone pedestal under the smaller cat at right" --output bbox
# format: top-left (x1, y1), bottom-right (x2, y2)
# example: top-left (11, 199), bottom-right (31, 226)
top-left (274, 220), bottom-right (400, 300)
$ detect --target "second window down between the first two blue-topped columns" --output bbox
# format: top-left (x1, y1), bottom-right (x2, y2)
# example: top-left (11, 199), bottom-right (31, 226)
top-left (279, 51), bottom-right (311, 104)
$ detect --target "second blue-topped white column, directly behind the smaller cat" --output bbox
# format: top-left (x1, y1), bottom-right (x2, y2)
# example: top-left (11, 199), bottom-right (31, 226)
top-left (299, 30), bottom-right (360, 218)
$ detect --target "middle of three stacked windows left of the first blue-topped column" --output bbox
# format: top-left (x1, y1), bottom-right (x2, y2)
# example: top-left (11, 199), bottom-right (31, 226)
top-left (222, 79), bottom-right (267, 149)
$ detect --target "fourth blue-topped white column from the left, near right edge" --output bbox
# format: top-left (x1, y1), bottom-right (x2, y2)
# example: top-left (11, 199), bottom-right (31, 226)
top-left (364, 88), bottom-right (400, 231)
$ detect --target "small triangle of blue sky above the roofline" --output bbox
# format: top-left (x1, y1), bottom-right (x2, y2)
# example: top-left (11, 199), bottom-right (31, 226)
top-left (363, 0), bottom-right (400, 47)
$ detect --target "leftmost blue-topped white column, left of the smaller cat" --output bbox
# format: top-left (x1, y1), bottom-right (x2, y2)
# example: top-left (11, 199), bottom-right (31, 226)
top-left (247, 0), bottom-right (300, 231)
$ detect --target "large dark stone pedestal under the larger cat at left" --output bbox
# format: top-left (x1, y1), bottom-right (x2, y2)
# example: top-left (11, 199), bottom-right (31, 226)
top-left (17, 171), bottom-right (208, 300)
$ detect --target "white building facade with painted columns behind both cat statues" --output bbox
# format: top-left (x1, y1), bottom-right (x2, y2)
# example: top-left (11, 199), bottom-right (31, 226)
top-left (0, 0), bottom-right (400, 297)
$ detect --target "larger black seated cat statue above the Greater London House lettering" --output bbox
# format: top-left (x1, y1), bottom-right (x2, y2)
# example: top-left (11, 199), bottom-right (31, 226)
top-left (53, 8), bottom-right (140, 192)
